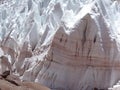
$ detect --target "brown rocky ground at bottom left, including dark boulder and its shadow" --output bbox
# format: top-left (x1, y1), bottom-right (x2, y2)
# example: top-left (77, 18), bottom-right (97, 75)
top-left (0, 71), bottom-right (50, 90)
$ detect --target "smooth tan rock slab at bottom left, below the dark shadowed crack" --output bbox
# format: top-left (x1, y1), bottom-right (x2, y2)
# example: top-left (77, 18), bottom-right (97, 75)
top-left (0, 79), bottom-right (50, 90)
